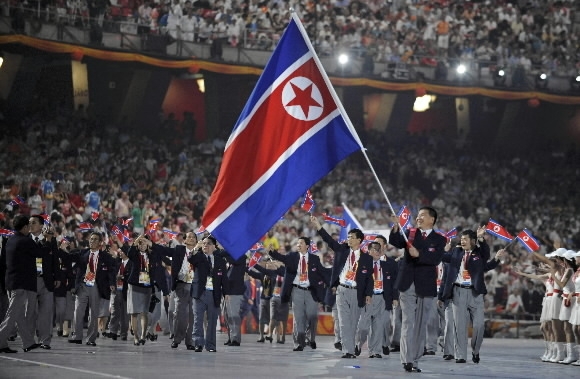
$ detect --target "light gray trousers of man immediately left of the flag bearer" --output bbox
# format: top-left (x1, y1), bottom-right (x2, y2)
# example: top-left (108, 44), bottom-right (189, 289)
top-left (356, 294), bottom-right (390, 355)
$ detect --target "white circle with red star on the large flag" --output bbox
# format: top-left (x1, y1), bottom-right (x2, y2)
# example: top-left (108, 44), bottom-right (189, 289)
top-left (282, 76), bottom-right (324, 121)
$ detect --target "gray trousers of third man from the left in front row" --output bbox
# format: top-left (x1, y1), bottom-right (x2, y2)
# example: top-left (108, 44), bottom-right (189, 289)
top-left (71, 283), bottom-right (101, 342)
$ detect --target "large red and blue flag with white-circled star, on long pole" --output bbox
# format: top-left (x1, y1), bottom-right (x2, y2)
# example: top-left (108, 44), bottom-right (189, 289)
top-left (203, 14), bottom-right (363, 258)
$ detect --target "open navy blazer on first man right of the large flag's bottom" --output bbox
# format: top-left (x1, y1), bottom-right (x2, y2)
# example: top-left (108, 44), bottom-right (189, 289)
top-left (270, 251), bottom-right (330, 303)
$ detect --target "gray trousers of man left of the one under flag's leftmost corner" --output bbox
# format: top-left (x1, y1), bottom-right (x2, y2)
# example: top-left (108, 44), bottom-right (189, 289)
top-left (169, 283), bottom-right (193, 345)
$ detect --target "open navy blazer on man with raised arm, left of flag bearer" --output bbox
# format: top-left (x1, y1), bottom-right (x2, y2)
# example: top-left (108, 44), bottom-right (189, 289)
top-left (318, 228), bottom-right (374, 307)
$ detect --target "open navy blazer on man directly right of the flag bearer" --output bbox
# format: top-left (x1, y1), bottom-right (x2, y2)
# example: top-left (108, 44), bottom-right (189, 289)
top-left (439, 241), bottom-right (499, 300)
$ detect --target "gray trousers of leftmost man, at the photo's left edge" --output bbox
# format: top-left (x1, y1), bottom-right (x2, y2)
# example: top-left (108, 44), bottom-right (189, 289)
top-left (0, 289), bottom-right (36, 349)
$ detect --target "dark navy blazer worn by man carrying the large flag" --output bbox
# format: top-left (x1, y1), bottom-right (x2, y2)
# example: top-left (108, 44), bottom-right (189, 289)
top-left (389, 229), bottom-right (447, 297)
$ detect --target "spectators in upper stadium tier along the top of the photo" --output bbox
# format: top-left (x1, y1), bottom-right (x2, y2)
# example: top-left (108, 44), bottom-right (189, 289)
top-left (5, 0), bottom-right (580, 75)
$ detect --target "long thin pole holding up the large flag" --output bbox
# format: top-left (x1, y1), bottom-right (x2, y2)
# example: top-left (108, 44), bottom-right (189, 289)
top-left (290, 12), bottom-right (409, 242)
